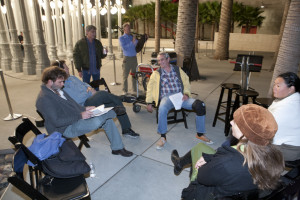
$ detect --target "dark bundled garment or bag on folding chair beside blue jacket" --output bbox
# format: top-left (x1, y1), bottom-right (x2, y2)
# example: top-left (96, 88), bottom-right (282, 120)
top-left (42, 140), bottom-right (90, 178)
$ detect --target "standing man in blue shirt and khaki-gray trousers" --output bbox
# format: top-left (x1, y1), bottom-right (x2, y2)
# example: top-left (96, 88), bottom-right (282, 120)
top-left (119, 23), bottom-right (138, 95)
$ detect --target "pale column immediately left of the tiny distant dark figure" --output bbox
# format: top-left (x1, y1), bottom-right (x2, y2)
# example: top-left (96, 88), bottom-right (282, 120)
top-left (4, 0), bottom-right (23, 73)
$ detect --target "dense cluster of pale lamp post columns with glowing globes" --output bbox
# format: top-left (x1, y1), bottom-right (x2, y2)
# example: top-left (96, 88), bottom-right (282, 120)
top-left (0, 0), bottom-right (125, 75)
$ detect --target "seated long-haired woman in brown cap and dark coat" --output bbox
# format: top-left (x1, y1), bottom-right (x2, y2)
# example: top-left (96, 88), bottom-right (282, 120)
top-left (171, 104), bottom-right (284, 200)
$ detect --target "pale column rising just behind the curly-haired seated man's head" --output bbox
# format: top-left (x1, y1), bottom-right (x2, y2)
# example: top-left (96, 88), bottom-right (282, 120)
top-left (32, 1), bottom-right (50, 76)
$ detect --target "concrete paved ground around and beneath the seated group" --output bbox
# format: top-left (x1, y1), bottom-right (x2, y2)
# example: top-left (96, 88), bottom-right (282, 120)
top-left (0, 44), bottom-right (273, 200)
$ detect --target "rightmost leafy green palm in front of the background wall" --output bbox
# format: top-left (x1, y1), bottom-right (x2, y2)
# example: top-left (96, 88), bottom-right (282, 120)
top-left (238, 6), bottom-right (265, 33)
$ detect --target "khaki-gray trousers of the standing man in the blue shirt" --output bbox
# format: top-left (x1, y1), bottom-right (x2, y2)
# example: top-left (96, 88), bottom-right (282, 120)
top-left (122, 56), bottom-right (138, 92)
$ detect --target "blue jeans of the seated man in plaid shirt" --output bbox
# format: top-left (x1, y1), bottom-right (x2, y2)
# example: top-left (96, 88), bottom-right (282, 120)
top-left (157, 96), bottom-right (206, 134)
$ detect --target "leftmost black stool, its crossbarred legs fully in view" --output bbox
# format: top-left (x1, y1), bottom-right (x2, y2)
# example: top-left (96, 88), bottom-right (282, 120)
top-left (213, 83), bottom-right (240, 134)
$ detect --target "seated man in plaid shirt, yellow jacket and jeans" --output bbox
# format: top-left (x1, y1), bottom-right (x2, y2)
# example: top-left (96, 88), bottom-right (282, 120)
top-left (146, 52), bottom-right (213, 149)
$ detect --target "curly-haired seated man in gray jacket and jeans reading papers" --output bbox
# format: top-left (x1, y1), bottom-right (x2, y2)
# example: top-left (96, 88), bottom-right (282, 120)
top-left (36, 67), bottom-right (133, 157)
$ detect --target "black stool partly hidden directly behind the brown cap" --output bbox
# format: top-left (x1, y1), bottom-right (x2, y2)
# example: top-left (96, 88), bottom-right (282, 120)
top-left (230, 89), bottom-right (259, 136)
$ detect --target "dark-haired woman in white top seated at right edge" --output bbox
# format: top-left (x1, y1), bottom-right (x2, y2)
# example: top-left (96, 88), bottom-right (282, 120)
top-left (268, 72), bottom-right (300, 161)
